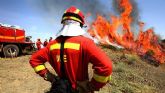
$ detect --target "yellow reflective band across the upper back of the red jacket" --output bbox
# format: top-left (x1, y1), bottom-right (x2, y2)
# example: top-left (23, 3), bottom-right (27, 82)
top-left (50, 43), bottom-right (80, 50)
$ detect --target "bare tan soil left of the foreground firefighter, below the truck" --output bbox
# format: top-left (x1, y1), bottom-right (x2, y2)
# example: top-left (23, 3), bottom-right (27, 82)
top-left (0, 56), bottom-right (50, 93)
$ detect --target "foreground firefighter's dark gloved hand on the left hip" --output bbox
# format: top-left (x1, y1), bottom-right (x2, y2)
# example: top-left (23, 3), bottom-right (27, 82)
top-left (44, 72), bottom-right (57, 83)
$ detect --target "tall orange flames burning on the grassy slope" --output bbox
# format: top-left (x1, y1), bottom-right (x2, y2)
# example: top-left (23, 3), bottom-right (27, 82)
top-left (88, 0), bottom-right (165, 63)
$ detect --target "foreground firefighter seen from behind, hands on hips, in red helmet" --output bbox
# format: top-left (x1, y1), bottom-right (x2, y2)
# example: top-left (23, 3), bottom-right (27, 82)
top-left (29, 6), bottom-right (112, 93)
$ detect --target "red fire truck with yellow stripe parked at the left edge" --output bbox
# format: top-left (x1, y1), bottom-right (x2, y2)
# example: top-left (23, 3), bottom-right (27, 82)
top-left (0, 23), bottom-right (34, 57)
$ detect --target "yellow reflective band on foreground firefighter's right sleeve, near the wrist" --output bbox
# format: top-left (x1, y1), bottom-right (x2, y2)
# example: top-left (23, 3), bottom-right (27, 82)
top-left (93, 73), bottom-right (111, 83)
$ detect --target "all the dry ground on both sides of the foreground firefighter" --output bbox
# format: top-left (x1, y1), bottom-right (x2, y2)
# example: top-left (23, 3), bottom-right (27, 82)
top-left (0, 48), bottom-right (165, 93)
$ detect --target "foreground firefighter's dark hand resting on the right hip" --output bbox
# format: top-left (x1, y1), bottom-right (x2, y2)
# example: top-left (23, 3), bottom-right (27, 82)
top-left (77, 80), bottom-right (96, 93)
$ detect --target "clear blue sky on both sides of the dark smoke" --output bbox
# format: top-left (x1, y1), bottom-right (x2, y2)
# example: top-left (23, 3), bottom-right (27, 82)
top-left (0, 0), bottom-right (165, 41)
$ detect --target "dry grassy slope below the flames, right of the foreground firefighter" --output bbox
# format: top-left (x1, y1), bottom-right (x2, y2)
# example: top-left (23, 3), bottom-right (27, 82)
top-left (99, 48), bottom-right (165, 93)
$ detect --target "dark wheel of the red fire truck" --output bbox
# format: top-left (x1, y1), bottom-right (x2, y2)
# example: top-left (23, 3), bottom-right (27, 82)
top-left (3, 44), bottom-right (19, 57)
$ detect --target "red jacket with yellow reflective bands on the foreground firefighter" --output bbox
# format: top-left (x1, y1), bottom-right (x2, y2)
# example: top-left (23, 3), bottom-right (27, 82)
top-left (30, 36), bottom-right (112, 89)
